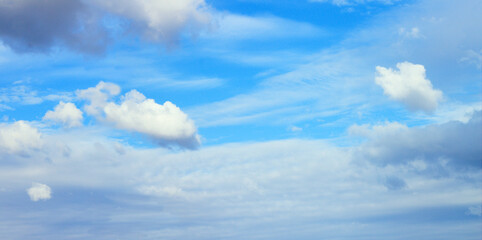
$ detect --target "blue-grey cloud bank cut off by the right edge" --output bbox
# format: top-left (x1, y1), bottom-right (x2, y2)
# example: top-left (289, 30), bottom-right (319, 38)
top-left (350, 111), bottom-right (482, 170)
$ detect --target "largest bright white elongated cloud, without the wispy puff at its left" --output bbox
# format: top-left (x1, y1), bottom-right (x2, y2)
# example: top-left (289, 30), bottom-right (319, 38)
top-left (104, 90), bottom-right (200, 148)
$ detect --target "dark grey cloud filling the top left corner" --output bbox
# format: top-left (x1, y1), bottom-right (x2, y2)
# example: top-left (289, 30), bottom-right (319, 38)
top-left (0, 0), bottom-right (107, 53)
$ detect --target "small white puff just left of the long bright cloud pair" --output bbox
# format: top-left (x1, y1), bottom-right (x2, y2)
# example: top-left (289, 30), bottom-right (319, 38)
top-left (42, 101), bottom-right (83, 128)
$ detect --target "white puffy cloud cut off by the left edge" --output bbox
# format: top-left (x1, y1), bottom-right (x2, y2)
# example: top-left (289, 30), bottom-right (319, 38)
top-left (0, 121), bottom-right (42, 153)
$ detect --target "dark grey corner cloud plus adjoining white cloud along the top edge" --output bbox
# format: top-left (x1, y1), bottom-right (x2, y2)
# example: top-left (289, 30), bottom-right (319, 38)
top-left (0, 0), bottom-right (210, 54)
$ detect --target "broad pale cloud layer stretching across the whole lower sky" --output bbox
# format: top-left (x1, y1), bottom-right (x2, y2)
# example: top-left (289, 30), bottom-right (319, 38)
top-left (0, 112), bottom-right (482, 239)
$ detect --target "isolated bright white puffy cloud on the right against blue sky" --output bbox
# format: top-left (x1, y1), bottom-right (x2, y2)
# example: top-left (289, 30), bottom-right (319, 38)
top-left (375, 62), bottom-right (442, 113)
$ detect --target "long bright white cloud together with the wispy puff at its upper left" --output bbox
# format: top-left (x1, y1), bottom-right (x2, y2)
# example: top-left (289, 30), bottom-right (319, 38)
top-left (77, 82), bottom-right (200, 149)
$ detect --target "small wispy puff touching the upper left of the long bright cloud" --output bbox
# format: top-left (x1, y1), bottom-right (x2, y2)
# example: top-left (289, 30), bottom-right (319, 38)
top-left (76, 81), bottom-right (120, 116)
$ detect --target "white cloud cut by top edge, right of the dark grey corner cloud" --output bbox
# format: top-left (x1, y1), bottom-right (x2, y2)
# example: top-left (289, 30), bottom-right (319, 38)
top-left (87, 0), bottom-right (211, 45)
